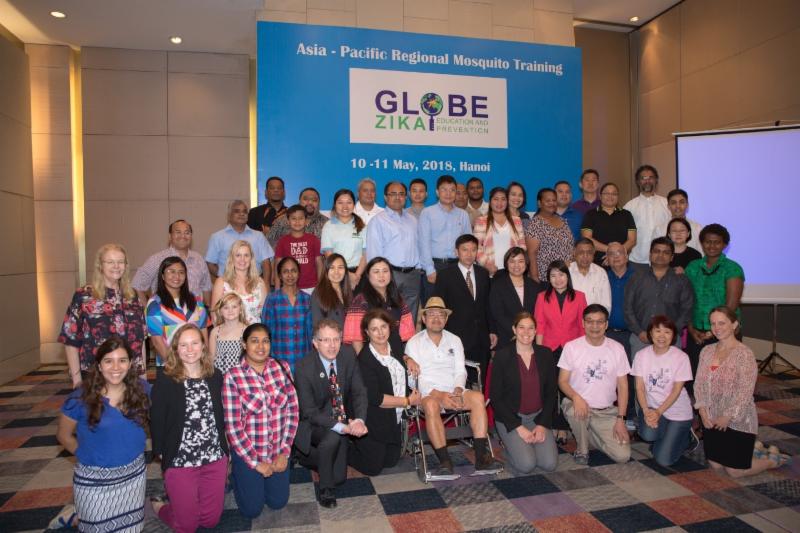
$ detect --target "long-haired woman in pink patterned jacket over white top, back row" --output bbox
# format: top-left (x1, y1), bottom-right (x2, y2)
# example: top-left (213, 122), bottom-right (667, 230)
top-left (472, 187), bottom-right (527, 276)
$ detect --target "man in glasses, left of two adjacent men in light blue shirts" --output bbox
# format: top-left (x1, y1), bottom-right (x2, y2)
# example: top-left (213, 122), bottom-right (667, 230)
top-left (367, 181), bottom-right (422, 322)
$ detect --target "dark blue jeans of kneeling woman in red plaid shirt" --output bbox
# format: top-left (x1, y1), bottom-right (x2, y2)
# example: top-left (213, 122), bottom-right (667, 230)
top-left (231, 452), bottom-right (291, 518)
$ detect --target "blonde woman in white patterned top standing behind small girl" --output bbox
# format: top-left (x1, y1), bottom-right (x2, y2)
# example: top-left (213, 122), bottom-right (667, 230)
top-left (211, 240), bottom-right (268, 324)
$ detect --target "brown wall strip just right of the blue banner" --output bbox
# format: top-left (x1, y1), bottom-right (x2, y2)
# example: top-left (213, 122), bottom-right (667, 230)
top-left (575, 28), bottom-right (631, 202)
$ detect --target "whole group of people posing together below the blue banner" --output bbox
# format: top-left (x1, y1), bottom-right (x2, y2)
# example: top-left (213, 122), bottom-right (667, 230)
top-left (57, 165), bottom-right (792, 532)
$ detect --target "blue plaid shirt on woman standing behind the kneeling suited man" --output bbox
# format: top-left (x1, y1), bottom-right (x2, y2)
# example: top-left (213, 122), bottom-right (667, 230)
top-left (261, 290), bottom-right (312, 372)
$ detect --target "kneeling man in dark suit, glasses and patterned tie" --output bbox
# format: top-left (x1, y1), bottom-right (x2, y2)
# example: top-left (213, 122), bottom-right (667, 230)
top-left (295, 318), bottom-right (367, 507)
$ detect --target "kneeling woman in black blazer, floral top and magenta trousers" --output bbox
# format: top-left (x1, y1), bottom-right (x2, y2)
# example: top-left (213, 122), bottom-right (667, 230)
top-left (150, 324), bottom-right (228, 533)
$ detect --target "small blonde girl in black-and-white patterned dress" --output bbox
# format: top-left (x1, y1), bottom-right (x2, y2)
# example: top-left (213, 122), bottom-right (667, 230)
top-left (208, 292), bottom-right (247, 374)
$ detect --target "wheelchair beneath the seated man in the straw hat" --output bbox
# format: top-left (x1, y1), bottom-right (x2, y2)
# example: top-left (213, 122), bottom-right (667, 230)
top-left (401, 360), bottom-right (494, 483)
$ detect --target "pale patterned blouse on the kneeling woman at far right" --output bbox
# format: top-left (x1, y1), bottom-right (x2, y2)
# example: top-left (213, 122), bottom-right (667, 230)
top-left (694, 343), bottom-right (758, 435)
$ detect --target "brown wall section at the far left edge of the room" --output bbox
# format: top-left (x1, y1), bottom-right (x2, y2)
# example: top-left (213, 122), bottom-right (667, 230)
top-left (0, 37), bottom-right (39, 383)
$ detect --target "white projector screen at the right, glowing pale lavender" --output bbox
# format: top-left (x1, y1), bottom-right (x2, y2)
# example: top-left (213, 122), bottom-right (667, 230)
top-left (676, 122), bottom-right (800, 303)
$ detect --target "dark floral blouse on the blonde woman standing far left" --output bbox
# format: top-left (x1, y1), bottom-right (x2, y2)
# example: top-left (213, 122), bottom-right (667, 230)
top-left (58, 286), bottom-right (145, 371)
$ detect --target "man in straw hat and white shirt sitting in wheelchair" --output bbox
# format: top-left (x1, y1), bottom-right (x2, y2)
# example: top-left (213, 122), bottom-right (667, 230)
top-left (404, 296), bottom-right (502, 476)
